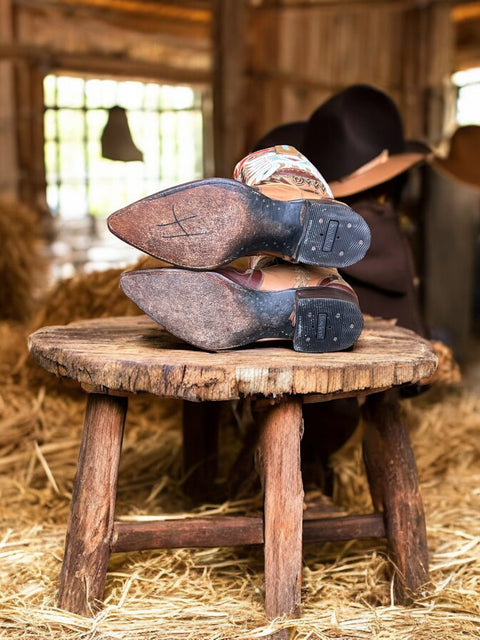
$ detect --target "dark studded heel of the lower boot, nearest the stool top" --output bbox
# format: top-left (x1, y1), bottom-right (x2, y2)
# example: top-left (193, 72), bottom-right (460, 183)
top-left (293, 287), bottom-right (363, 353)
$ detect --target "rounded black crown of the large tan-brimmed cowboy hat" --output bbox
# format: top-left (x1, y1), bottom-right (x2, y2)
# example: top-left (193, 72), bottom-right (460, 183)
top-left (304, 85), bottom-right (406, 181)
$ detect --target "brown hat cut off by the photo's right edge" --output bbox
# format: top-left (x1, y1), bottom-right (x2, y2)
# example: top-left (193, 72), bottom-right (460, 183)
top-left (432, 124), bottom-right (480, 187)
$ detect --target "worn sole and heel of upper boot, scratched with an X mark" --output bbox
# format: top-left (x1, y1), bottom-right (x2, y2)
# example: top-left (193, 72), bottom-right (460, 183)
top-left (108, 178), bottom-right (370, 270)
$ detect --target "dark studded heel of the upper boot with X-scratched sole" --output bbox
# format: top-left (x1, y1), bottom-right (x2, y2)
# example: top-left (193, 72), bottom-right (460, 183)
top-left (296, 200), bottom-right (370, 267)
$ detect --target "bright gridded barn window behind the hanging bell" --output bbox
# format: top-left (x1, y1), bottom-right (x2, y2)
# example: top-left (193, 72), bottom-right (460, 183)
top-left (44, 75), bottom-right (208, 275)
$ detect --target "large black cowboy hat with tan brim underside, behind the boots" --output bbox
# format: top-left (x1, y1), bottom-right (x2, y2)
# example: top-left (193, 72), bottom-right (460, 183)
top-left (255, 84), bottom-right (430, 197)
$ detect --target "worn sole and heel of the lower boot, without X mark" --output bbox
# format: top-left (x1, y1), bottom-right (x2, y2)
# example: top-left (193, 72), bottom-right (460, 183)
top-left (120, 269), bottom-right (363, 353)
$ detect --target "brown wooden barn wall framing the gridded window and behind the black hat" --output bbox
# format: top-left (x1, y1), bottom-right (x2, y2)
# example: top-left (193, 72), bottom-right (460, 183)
top-left (0, 0), bottom-right (453, 196)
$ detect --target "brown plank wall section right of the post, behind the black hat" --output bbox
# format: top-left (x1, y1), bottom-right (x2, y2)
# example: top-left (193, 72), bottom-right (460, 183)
top-left (227, 0), bottom-right (453, 175)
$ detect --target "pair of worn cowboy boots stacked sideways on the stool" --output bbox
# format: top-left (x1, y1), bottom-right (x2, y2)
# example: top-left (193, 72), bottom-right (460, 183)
top-left (108, 147), bottom-right (370, 353)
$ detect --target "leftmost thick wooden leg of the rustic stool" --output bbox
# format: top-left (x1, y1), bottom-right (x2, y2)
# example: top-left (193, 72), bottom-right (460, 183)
top-left (59, 393), bottom-right (127, 616)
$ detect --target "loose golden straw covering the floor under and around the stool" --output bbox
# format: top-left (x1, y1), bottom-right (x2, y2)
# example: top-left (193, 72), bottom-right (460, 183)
top-left (0, 274), bottom-right (480, 640)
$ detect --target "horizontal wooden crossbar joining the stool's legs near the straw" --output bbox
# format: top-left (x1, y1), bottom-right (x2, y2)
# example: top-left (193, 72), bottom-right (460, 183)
top-left (111, 511), bottom-right (385, 553)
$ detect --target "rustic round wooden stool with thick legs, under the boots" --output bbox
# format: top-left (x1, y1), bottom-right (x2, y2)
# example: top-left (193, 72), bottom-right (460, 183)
top-left (29, 316), bottom-right (436, 618)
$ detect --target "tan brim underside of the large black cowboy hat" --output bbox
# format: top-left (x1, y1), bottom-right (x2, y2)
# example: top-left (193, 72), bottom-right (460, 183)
top-left (328, 152), bottom-right (425, 198)
